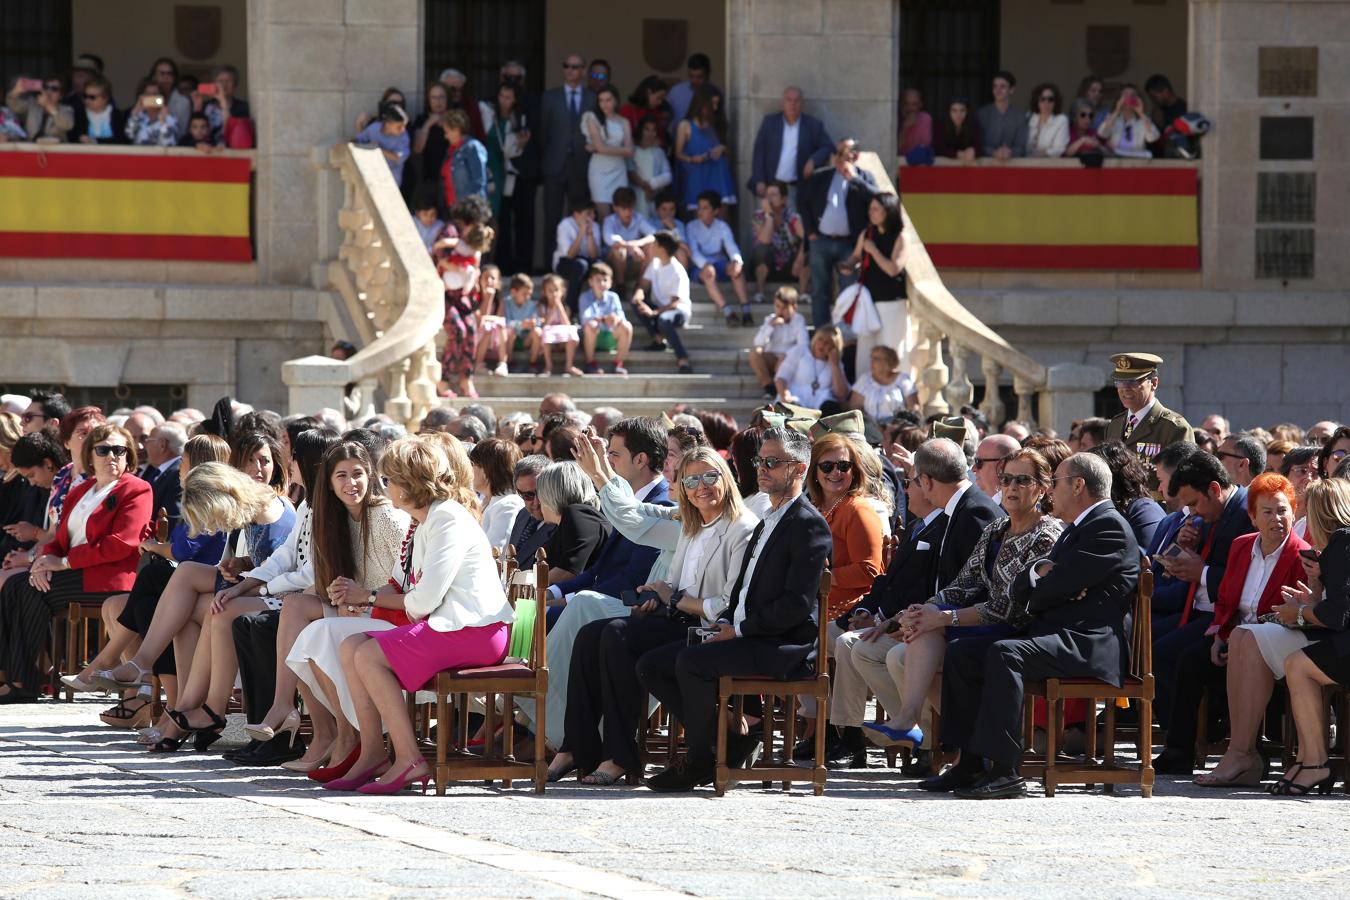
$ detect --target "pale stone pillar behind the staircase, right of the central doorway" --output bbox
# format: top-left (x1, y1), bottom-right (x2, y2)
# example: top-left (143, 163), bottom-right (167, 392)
top-left (726, 0), bottom-right (900, 195)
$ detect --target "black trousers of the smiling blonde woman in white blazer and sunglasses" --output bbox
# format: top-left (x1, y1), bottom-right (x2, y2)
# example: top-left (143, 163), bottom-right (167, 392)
top-left (560, 614), bottom-right (690, 773)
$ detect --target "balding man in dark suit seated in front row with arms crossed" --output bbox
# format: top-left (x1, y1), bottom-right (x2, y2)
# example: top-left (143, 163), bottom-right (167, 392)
top-left (919, 453), bottom-right (1139, 800)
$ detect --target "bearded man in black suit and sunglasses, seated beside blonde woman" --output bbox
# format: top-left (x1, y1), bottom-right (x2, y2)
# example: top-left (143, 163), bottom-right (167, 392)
top-left (637, 428), bottom-right (834, 792)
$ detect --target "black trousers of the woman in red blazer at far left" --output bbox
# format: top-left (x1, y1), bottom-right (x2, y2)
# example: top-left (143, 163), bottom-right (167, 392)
top-left (0, 569), bottom-right (112, 692)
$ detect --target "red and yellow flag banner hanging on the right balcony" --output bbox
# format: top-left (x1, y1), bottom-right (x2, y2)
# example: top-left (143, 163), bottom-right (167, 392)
top-left (900, 165), bottom-right (1200, 270)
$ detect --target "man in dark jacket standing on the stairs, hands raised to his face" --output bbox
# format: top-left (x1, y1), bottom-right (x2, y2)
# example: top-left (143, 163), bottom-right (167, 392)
top-left (797, 138), bottom-right (876, 328)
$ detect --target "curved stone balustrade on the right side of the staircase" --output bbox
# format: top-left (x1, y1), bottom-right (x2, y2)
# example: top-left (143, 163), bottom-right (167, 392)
top-left (859, 152), bottom-right (1103, 434)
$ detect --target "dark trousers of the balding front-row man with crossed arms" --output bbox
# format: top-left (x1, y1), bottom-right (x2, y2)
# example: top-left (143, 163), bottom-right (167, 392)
top-left (942, 634), bottom-right (1117, 769)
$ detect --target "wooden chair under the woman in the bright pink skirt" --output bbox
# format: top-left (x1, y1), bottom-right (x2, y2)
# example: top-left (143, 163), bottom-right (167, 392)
top-left (435, 551), bottom-right (548, 795)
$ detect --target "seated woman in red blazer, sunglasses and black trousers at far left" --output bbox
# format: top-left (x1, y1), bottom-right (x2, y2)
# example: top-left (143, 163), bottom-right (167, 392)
top-left (0, 422), bottom-right (154, 703)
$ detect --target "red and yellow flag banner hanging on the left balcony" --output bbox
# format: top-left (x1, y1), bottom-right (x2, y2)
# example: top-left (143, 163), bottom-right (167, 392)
top-left (0, 148), bottom-right (252, 262)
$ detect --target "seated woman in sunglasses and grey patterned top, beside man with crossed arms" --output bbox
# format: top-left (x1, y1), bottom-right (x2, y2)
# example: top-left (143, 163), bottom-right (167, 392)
top-left (863, 449), bottom-right (1064, 746)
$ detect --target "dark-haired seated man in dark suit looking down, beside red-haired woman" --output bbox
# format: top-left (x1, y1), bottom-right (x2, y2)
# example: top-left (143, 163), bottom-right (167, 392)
top-left (1153, 451), bottom-right (1256, 775)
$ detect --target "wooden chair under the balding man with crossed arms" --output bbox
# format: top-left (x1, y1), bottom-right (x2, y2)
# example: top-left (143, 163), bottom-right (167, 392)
top-left (1023, 565), bottom-right (1154, 797)
